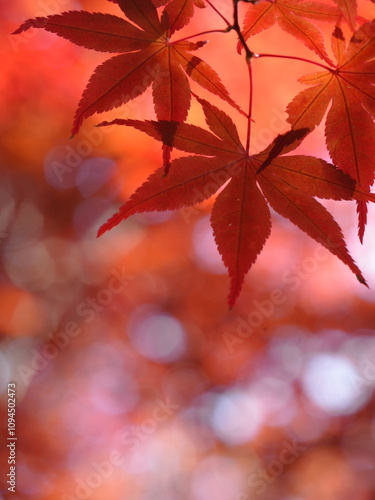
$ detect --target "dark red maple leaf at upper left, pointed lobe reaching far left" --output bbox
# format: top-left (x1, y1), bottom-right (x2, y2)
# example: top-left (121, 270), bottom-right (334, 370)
top-left (14, 0), bottom-right (240, 139)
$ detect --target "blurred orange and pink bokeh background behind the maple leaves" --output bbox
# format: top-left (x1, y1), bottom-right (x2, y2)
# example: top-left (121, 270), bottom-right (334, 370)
top-left (0, 0), bottom-right (375, 500)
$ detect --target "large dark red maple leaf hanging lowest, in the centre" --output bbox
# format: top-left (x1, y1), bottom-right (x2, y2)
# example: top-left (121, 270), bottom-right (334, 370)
top-left (98, 99), bottom-right (375, 307)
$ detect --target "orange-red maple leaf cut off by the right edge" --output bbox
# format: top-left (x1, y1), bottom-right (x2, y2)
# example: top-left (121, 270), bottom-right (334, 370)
top-left (287, 21), bottom-right (375, 241)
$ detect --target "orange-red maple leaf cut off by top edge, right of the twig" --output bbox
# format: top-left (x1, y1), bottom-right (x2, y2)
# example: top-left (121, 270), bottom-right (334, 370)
top-left (239, 0), bottom-right (340, 64)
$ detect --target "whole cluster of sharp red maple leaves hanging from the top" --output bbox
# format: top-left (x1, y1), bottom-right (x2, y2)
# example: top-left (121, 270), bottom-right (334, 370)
top-left (15, 0), bottom-right (375, 306)
